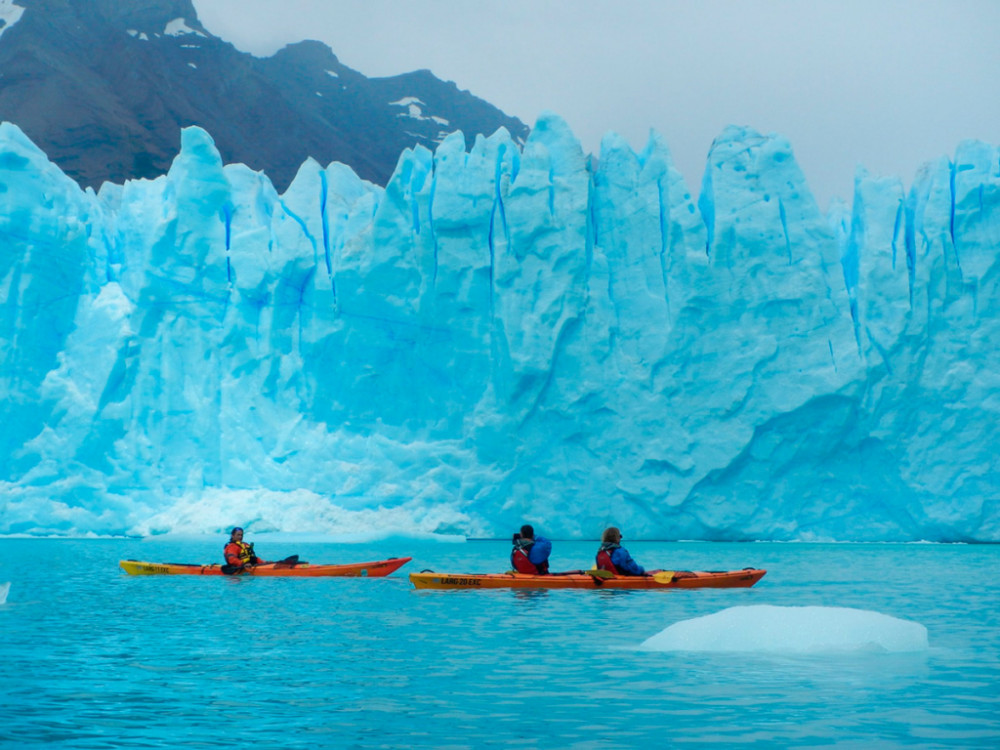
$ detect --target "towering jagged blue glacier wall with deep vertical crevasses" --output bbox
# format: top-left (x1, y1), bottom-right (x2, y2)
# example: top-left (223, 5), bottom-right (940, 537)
top-left (0, 117), bottom-right (1000, 541)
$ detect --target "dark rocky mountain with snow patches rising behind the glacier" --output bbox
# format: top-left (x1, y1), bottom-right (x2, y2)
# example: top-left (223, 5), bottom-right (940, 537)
top-left (0, 0), bottom-right (528, 191)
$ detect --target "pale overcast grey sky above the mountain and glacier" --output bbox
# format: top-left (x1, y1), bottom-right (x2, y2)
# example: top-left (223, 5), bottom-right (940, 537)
top-left (194, 0), bottom-right (1000, 209)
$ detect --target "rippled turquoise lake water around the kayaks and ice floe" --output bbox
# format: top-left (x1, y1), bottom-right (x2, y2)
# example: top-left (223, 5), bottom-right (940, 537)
top-left (0, 534), bottom-right (1000, 749)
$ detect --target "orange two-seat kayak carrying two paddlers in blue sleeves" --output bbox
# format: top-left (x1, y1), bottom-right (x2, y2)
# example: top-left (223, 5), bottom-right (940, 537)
top-left (410, 568), bottom-right (767, 589)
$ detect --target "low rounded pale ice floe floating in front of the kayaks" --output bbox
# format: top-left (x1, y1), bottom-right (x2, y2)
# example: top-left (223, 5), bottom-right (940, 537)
top-left (639, 604), bottom-right (927, 653)
